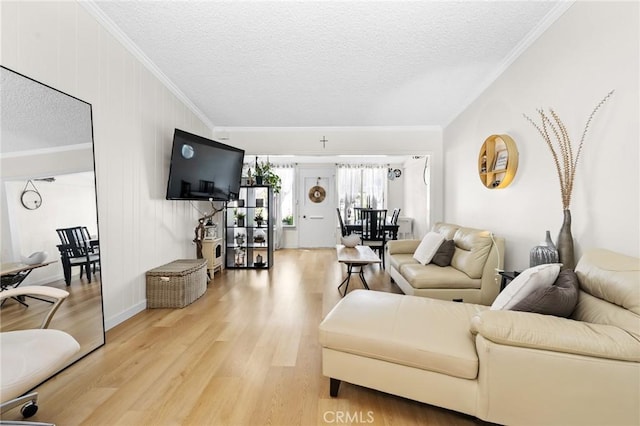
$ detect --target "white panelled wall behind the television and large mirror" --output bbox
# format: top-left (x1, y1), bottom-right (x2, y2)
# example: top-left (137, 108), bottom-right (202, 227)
top-left (0, 1), bottom-right (211, 328)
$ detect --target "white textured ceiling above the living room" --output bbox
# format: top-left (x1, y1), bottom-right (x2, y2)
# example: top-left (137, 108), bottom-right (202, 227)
top-left (92, 1), bottom-right (567, 127)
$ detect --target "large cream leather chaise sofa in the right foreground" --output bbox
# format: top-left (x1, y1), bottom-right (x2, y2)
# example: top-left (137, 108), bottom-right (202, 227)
top-left (320, 250), bottom-right (640, 425)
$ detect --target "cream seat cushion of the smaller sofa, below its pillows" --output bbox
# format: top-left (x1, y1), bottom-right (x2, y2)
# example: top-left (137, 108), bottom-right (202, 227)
top-left (399, 263), bottom-right (482, 289)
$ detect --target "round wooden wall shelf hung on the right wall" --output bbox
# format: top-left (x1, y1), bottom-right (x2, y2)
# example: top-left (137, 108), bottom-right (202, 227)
top-left (478, 135), bottom-right (518, 189)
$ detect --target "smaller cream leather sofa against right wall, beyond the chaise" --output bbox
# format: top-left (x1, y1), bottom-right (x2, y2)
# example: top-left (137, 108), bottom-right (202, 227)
top-left (385, 222), bottom-right (504, 305)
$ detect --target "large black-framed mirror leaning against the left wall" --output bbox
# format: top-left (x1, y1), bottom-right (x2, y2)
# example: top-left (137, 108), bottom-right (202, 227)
top-left (0, 67), bottom-right (105, 374)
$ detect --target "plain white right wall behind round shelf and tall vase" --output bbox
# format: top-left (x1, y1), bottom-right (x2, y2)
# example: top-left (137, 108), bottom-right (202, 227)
top-left (444, 2), bottom-right (640, 269)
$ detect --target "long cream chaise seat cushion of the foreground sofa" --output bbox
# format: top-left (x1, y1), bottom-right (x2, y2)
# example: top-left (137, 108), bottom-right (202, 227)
top-left (319, 290), bottom-right (487, 379)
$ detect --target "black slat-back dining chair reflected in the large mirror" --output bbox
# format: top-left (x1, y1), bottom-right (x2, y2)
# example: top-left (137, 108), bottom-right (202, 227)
top-left (56, 226), bottom-right (100, 285)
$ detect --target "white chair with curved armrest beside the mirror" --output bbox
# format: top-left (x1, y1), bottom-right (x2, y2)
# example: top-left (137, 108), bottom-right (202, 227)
top-left (0, 286), bottom-right (80, 424)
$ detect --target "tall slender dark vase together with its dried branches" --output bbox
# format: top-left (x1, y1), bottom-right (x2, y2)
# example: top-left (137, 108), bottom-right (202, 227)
top-left (523, 90), bottom-right (614, 269)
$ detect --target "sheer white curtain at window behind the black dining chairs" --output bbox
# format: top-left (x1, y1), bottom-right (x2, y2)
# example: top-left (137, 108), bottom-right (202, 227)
top-left (337, 164), bottom-right (387, 223)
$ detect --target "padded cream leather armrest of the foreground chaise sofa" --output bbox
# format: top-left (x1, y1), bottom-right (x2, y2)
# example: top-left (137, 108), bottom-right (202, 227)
top-left (471, 310), bottom-right (640, 362)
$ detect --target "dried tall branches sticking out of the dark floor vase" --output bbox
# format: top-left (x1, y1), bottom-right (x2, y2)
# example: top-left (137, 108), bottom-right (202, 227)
top-left (523, 90), bottom-right (614, 210)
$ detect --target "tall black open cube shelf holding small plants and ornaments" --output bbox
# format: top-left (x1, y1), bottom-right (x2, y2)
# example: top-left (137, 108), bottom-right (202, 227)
top-left (224, 185), bottom-right (275, 269)
